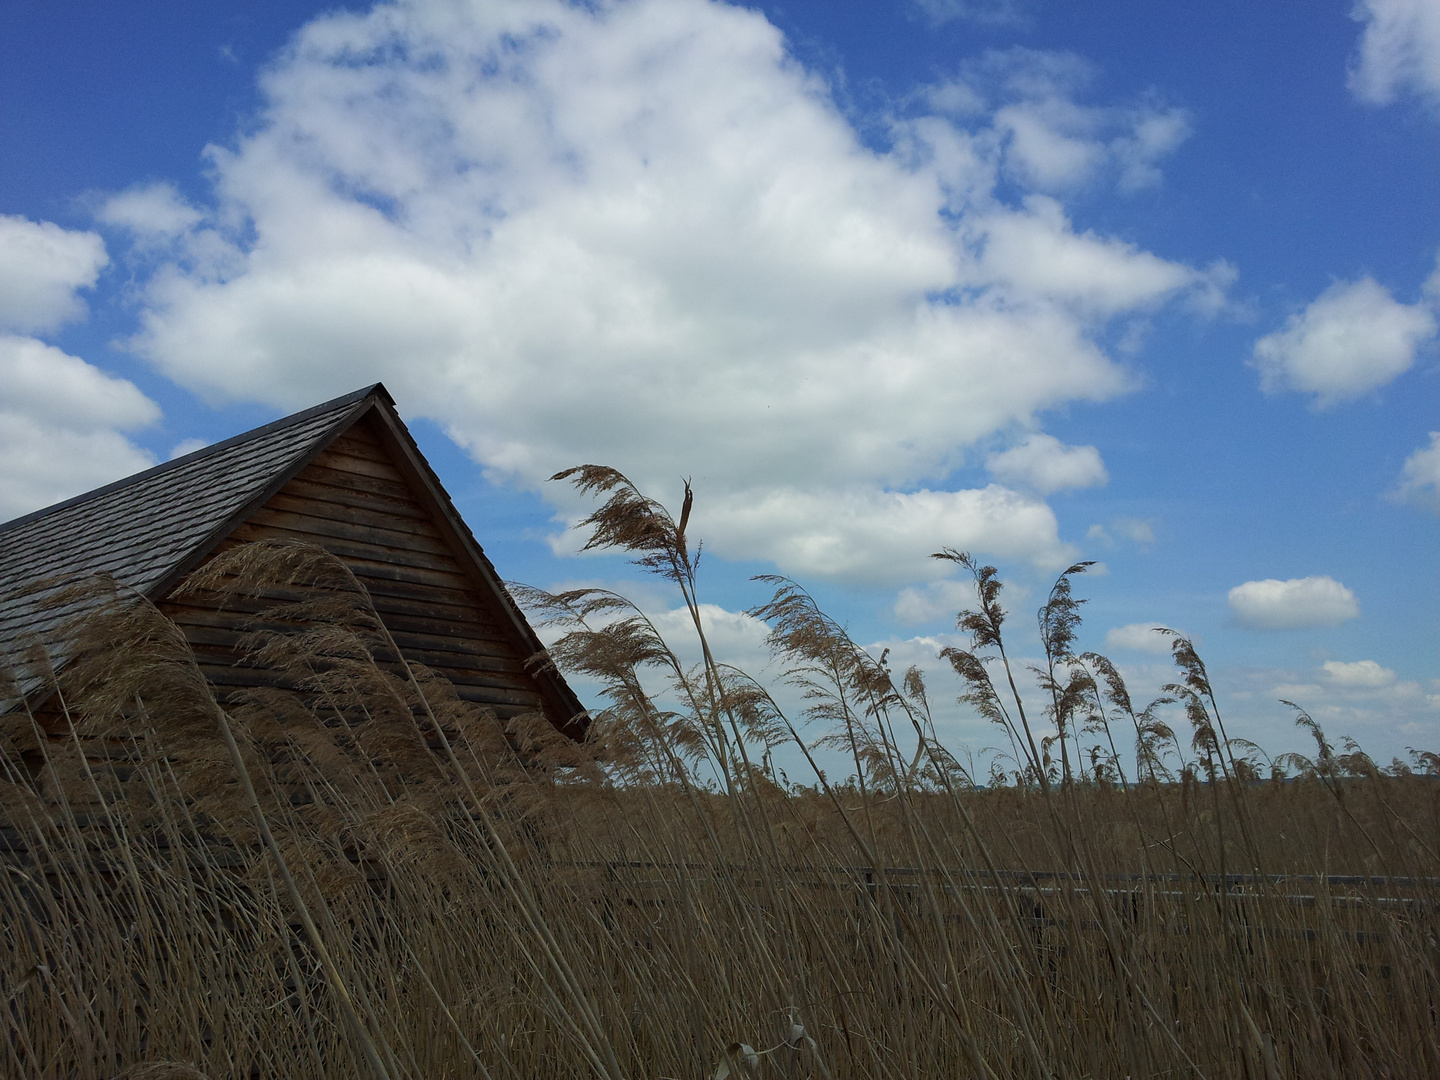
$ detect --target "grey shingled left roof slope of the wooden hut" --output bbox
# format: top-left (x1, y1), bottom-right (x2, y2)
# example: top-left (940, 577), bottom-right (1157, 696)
top-left (0, 384), bottom-right (389, 710)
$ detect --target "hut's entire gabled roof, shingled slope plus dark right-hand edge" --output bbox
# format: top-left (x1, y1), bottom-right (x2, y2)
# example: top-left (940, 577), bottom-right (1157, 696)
top-left (0, 383), bottom-right (583, 724)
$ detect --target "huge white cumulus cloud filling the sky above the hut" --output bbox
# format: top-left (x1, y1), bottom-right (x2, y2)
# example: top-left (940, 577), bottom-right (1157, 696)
top-left (109, 0), bottom-right (1215, 580)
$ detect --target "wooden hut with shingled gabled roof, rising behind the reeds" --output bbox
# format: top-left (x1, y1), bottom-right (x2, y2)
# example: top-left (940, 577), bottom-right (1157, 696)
top-left (0, 383), bottom-right (588, 737)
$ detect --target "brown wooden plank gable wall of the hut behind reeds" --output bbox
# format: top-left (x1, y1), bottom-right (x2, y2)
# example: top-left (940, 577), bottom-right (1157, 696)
top-left (160, 419), bottom-right (550, 726)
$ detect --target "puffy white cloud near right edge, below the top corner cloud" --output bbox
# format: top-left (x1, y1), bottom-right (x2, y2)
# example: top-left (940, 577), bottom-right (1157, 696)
top-left (1253, 278), bottom-right (1436, 409)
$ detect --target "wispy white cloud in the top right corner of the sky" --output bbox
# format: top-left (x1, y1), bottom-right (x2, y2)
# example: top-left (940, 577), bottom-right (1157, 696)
top-left (1349, 0), bottom-right (1440, 105)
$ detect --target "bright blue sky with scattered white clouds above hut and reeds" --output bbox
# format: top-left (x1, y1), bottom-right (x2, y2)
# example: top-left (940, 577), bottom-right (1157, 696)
top-left (0, 0), bottom-right (1440, 760)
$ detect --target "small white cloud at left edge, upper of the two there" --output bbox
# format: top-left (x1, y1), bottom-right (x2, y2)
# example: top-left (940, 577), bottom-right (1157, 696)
top-left (0, 215), bottom-right (109, 334)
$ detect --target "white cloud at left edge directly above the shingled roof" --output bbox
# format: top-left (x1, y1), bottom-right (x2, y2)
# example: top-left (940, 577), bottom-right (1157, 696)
top-left (0, 334), bottom-right (160, 521)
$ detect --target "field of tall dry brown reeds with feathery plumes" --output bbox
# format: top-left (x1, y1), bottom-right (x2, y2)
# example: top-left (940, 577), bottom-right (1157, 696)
top-left (0, 468), bottom-right (1440, 1080)
